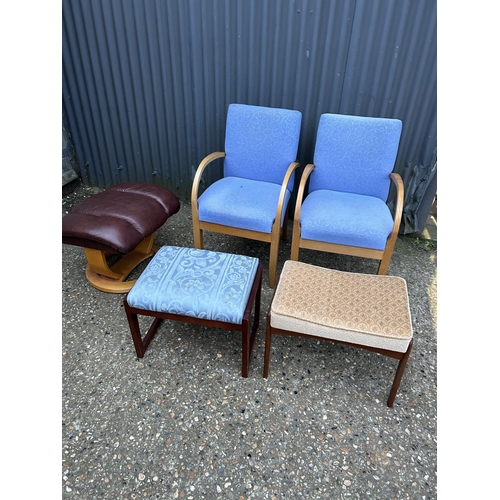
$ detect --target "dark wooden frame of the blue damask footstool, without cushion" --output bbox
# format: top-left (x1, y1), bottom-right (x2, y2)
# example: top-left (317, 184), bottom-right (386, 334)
top-left (123, 263), bottom-right (263, 378)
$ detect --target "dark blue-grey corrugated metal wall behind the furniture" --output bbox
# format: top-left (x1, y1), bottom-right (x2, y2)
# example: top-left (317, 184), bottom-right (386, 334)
top-left (62, 0), bottom-right (437, 233)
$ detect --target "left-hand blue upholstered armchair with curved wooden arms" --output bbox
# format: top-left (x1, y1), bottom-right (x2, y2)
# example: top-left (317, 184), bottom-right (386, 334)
top-left (191, 104), bottom-right (302, 287)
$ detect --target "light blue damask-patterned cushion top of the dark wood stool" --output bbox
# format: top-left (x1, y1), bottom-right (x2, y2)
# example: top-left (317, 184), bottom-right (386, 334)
top-left (127, 246), bottom-right (259, 324)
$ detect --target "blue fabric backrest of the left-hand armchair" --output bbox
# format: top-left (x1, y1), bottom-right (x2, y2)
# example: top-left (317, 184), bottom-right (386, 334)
top-left (224, 104), bottom-right (302, 191)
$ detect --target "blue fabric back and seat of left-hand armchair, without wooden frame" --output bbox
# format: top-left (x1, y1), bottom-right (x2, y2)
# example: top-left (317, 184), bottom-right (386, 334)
top-left (198, 104), bottom-right (302, 234)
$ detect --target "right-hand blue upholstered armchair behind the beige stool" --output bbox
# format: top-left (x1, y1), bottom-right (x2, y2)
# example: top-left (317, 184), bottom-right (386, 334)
top-left (291, 114), bottom-right (404, 274)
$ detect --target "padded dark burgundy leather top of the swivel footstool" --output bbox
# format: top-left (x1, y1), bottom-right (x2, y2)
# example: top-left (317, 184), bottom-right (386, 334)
top-left (62, 182), bottom-right (180, 254)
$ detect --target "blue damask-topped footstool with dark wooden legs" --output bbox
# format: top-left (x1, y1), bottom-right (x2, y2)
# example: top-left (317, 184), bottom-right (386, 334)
top-left (123, 246), bottom-right (262, 377)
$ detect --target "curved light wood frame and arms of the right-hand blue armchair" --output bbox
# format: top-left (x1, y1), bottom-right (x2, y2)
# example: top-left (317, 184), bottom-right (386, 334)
top-left (290, 168), bottom-right (404, 274)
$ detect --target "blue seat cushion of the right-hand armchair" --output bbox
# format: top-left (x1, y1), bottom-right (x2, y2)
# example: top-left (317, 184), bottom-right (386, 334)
top-left (300, 189), bottom-right (394, 250)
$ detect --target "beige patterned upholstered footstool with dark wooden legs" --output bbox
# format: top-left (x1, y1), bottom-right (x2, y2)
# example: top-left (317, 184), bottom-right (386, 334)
top-left (264, 260), bottom-right (413, 406)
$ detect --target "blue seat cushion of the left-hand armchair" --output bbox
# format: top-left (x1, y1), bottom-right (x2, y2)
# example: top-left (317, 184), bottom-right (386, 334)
top-left (198, 177), bottom-right (291, 234)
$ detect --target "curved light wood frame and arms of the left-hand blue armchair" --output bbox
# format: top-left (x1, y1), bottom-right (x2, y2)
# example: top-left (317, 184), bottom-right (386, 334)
top-left (191, 151), bottom-right (300, 288)
